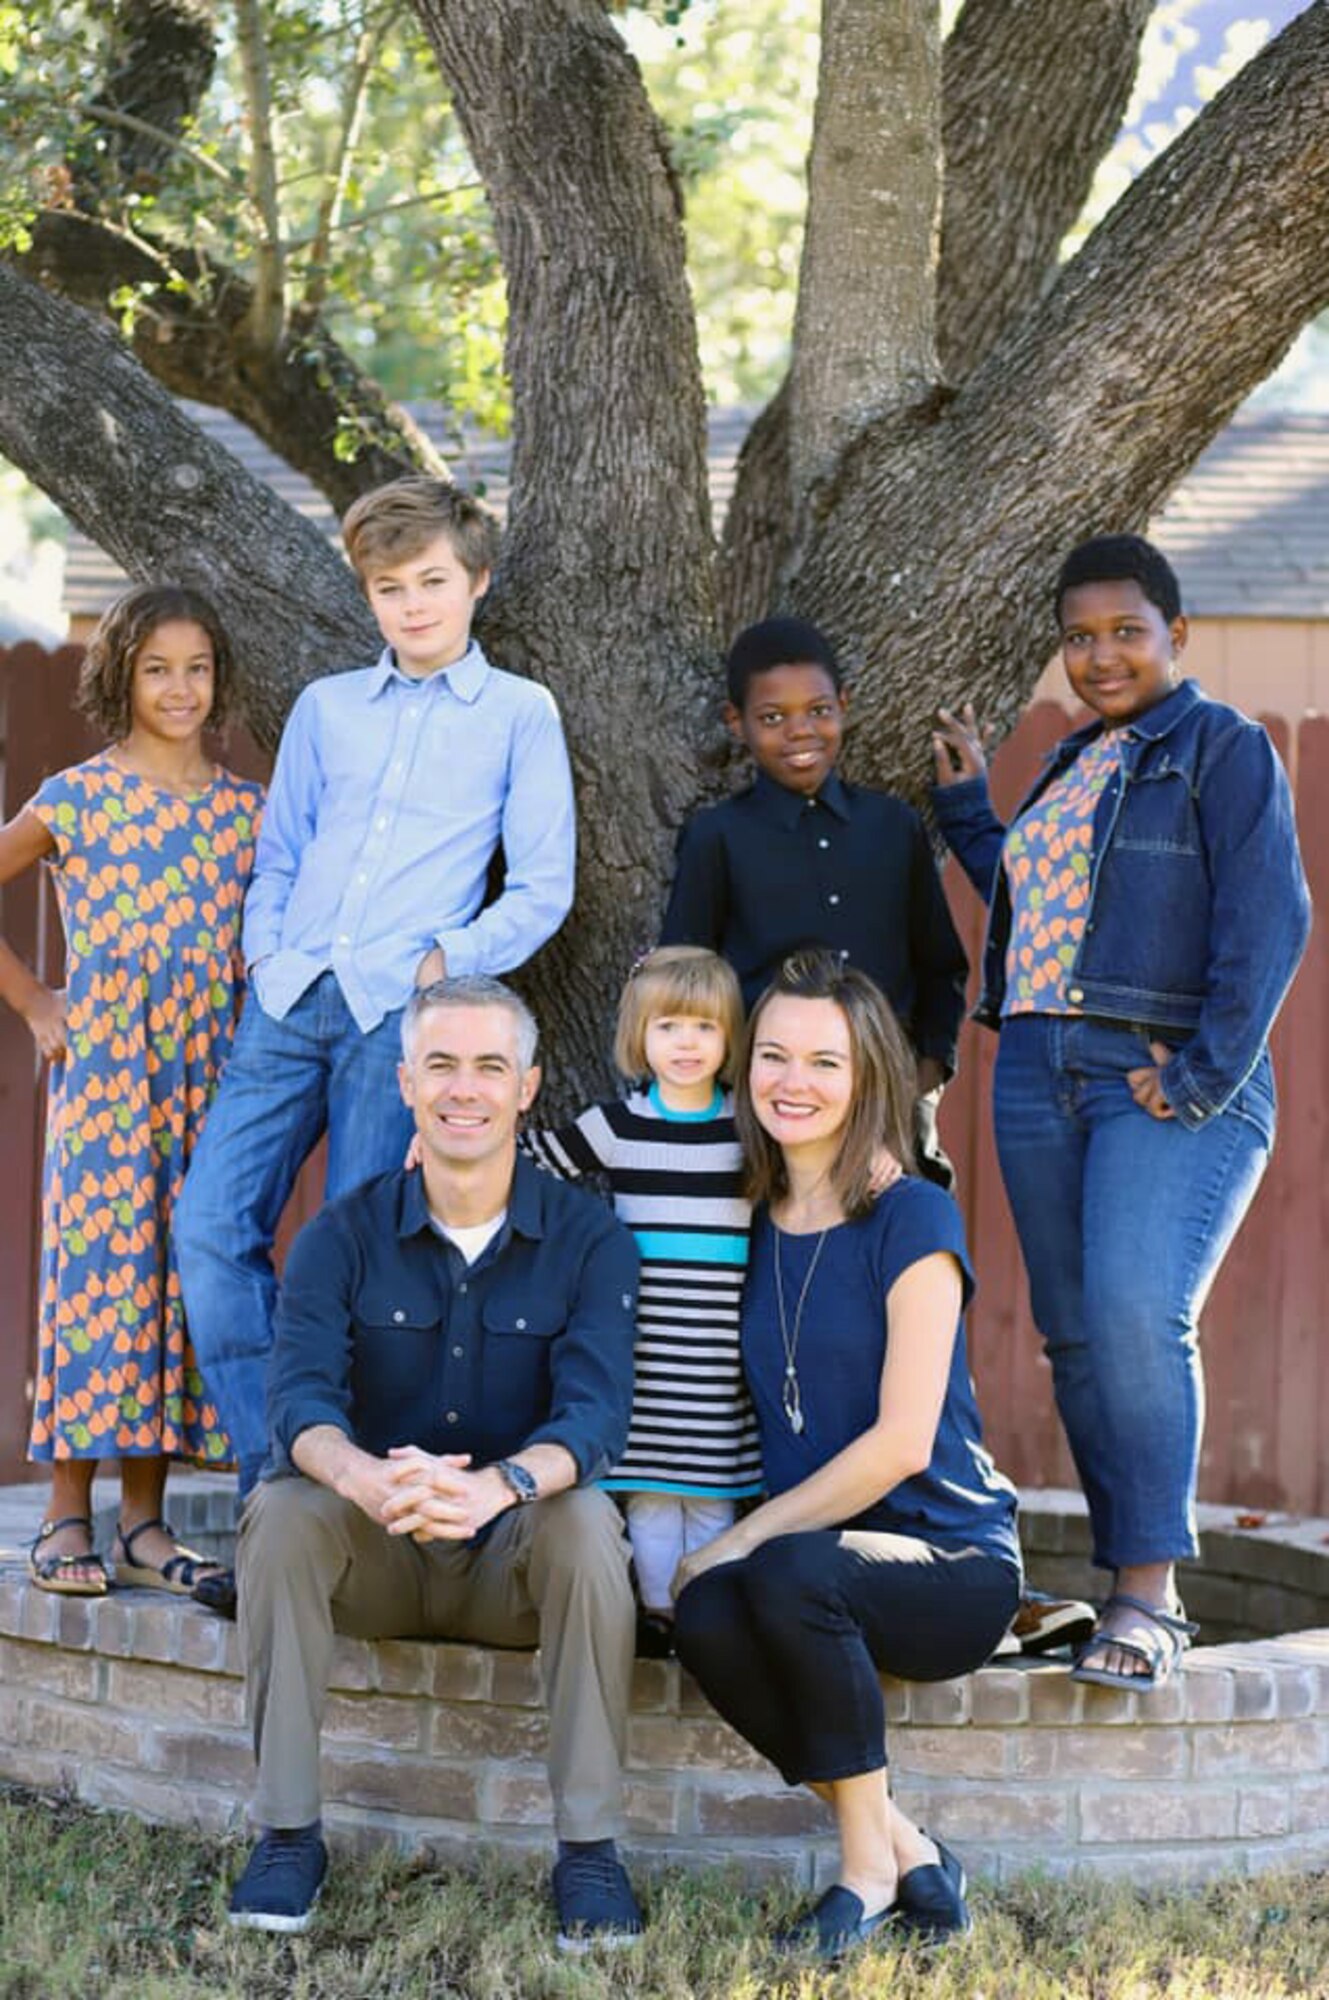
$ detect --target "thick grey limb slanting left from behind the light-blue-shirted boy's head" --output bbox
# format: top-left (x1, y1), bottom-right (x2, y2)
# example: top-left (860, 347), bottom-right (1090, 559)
top-left (0, 264), bottom-right (378, 744)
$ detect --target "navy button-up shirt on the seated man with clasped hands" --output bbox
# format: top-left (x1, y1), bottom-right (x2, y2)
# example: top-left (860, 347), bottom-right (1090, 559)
top-left (268, 1160), bottom-right (638, 1480)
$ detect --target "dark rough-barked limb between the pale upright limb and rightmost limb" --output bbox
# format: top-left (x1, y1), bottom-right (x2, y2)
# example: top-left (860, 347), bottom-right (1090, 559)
top-left (937, 0), bottom-right (1155, 382)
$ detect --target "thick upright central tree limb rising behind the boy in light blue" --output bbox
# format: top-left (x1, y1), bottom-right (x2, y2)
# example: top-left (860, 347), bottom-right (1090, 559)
top-left (414, 0), bottom-right (717, 1096)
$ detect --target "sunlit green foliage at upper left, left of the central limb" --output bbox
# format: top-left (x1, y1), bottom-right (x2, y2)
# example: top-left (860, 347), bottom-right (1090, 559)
top-left (0, 0), bottom-right (506, 430)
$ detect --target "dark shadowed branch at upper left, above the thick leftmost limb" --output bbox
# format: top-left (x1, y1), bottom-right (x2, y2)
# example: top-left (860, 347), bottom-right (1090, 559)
top-left (22, 208), bottom-right (446, 512)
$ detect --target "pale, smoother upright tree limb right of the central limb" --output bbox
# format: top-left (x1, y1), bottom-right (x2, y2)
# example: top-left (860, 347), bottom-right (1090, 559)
top-left (789, 0), bottom-right (941, 506)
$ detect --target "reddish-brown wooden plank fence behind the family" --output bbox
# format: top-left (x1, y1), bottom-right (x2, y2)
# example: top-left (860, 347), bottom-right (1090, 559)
top-left (0, 646), bottom-right (1329, 1514)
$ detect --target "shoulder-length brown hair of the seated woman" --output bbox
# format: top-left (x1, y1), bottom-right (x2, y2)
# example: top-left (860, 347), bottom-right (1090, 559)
top-left (735, 952), bottom-right (919, 1222)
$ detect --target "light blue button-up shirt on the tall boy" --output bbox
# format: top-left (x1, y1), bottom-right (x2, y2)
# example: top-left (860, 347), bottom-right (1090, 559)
top-left (244, 642), bottom-right (576, 1034)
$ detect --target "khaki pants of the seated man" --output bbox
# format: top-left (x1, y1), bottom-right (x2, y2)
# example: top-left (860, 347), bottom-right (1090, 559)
top-left (236, 1478), bottom-right (634, 1840)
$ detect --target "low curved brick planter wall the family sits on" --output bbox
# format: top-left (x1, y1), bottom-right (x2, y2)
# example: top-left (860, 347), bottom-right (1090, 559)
top-left (0, 1568), bottom-right (1329, 1884)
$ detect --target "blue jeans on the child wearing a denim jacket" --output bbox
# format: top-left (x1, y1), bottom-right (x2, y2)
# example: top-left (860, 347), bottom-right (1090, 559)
top-left (993, 1014), bottom-right (1273, 1570)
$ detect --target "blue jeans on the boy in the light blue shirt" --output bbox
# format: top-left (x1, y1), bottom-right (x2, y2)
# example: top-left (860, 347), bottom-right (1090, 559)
top-left (174, 972), bottom-right (412, 1494)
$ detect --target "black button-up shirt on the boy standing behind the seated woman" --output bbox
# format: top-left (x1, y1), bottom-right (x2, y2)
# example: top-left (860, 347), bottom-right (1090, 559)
top-left (660, 772), bottom-right (969, 1070)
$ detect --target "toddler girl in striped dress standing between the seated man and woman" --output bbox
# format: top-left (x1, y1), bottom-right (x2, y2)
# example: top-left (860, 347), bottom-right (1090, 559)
top-left (522, 944), bottom-right (763, 1652)
